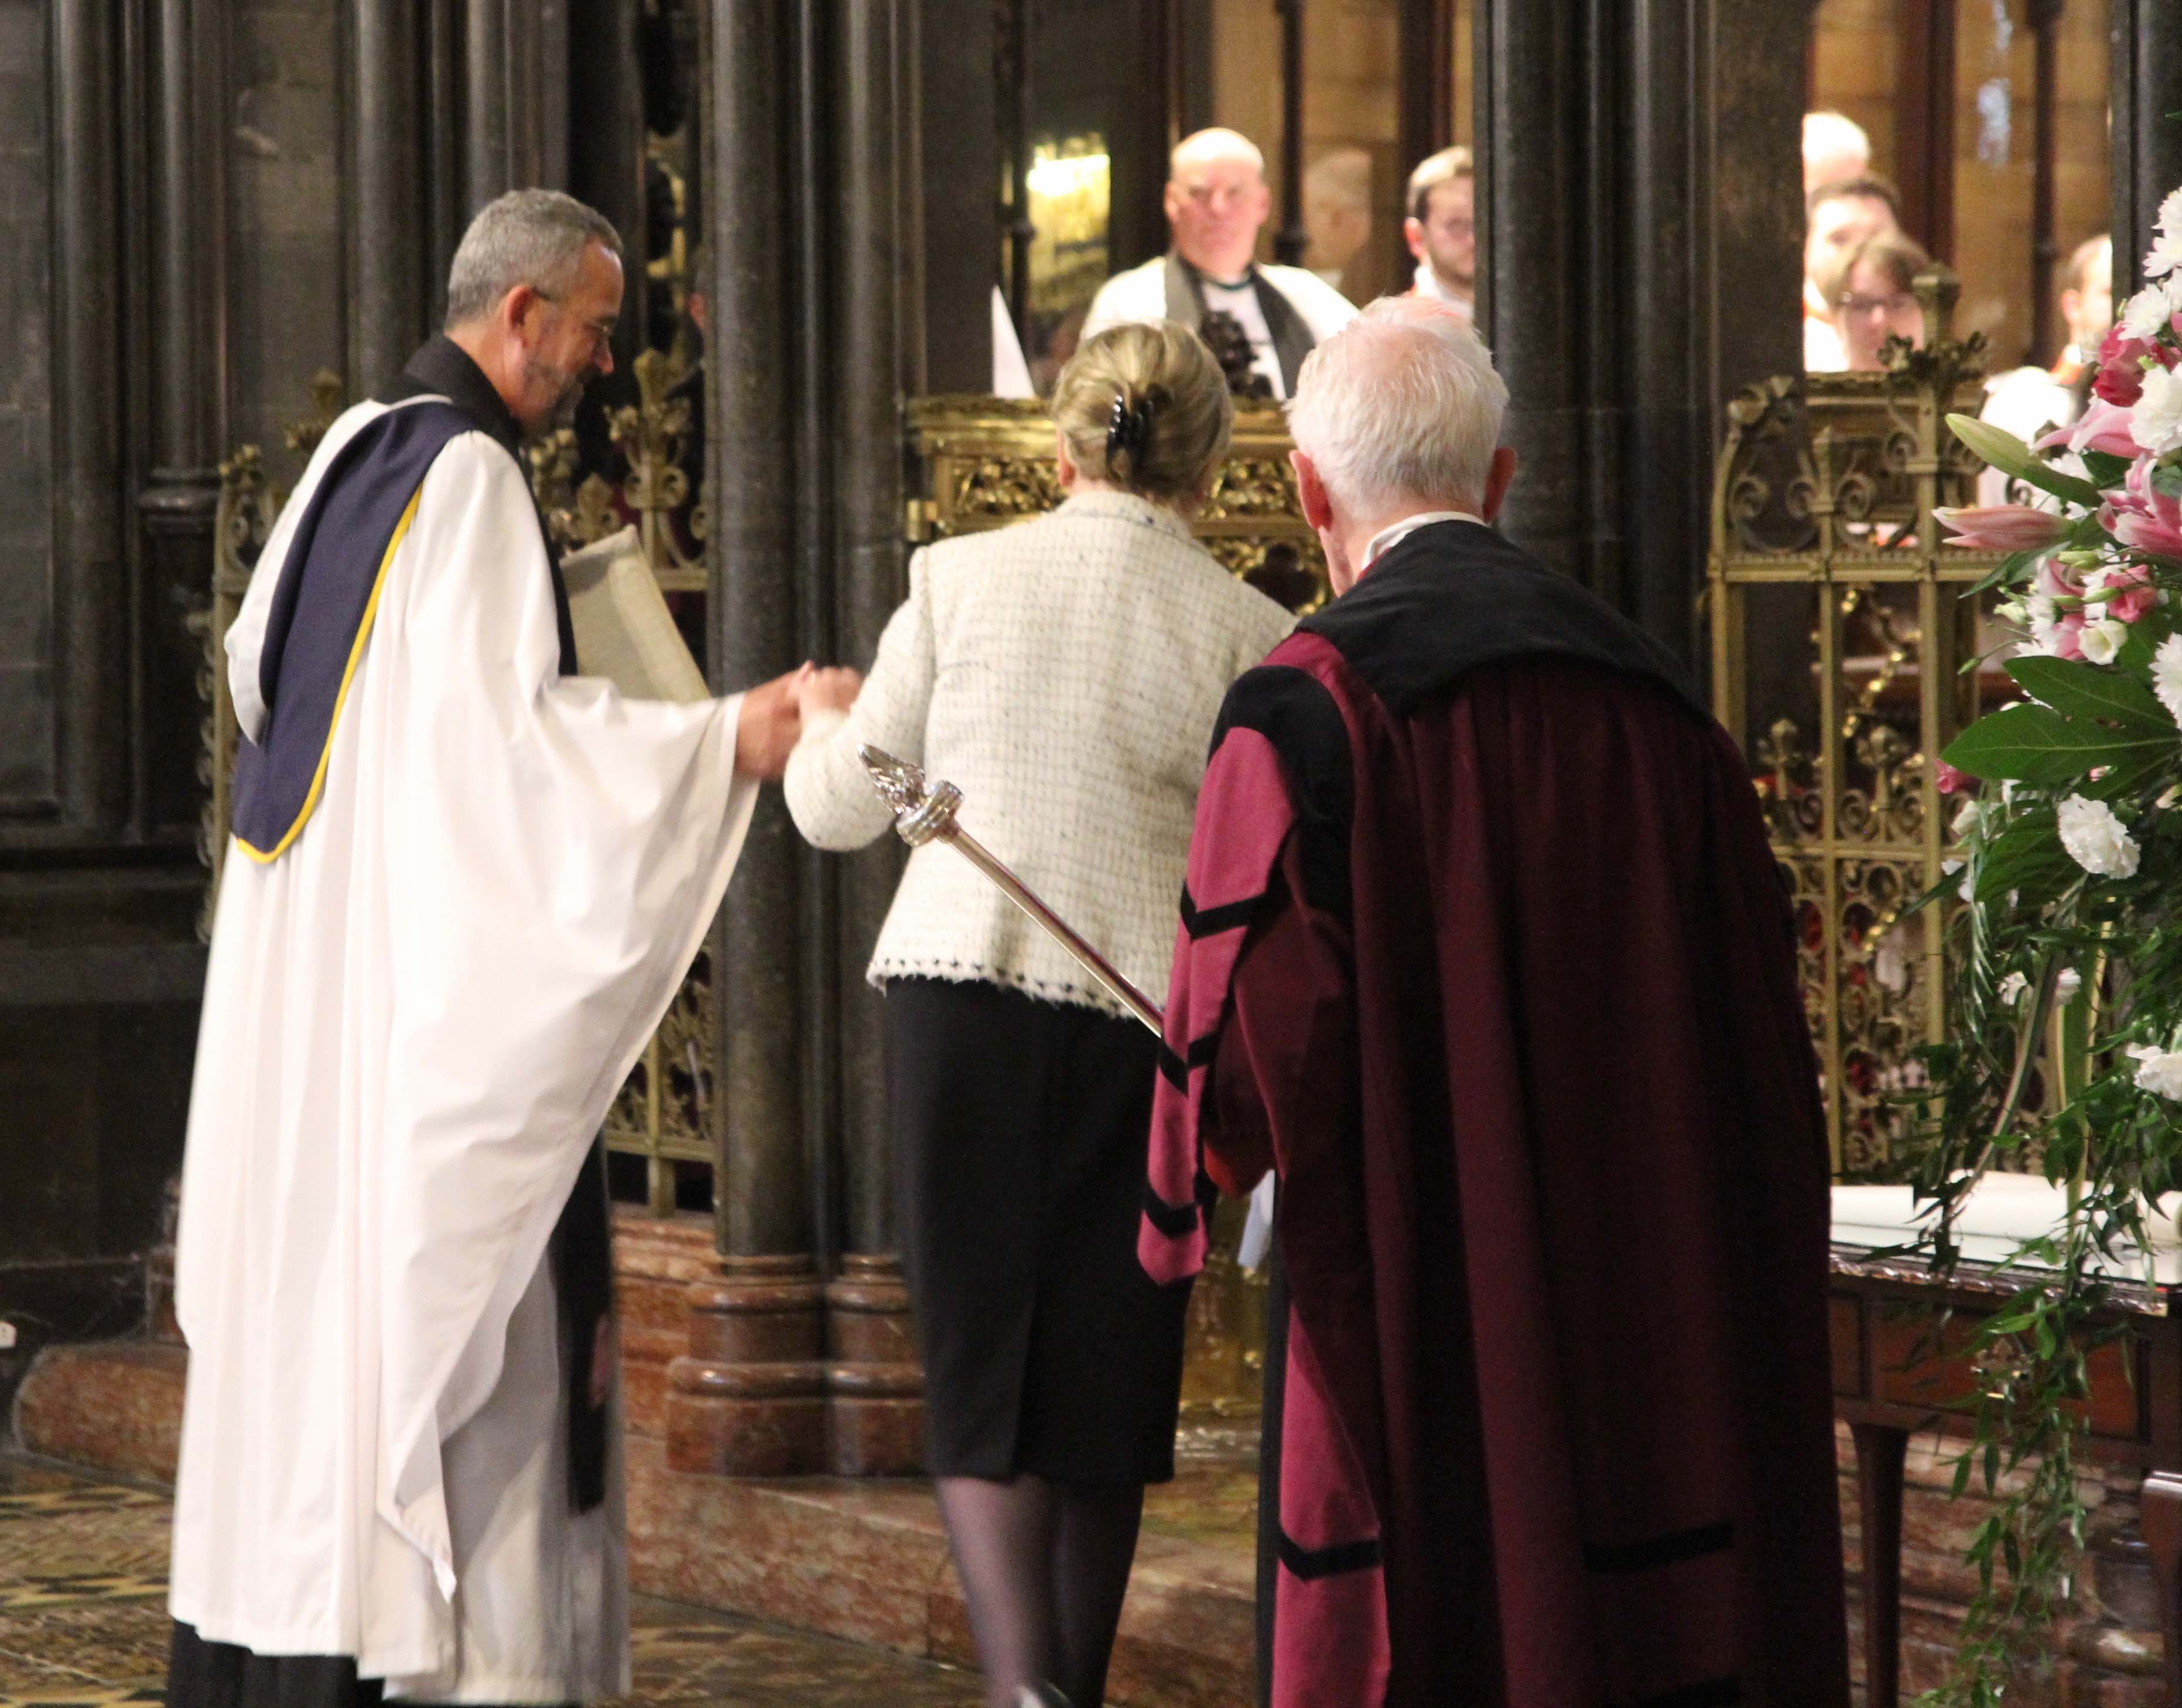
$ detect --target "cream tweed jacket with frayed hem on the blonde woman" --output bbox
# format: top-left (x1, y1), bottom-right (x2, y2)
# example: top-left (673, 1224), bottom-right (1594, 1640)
top-left (785, 491), bottom-right (1294, 1014)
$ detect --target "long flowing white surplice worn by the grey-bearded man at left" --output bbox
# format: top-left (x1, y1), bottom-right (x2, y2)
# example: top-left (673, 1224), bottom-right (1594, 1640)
top-left (170, 403), bottom-right (757, 1702)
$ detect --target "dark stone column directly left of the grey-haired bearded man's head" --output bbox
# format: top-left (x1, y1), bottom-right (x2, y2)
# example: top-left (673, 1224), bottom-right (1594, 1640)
top-left (340, 0), bottom-right (430, 397)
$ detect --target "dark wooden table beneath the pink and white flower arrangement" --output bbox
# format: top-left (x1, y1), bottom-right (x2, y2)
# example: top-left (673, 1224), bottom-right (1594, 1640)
top-left (1831, 1245), bottom-right (2182, 1708)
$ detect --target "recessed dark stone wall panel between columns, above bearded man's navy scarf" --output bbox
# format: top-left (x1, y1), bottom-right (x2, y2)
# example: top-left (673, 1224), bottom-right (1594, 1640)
top-left (227, 0), bottom-right (345, 460)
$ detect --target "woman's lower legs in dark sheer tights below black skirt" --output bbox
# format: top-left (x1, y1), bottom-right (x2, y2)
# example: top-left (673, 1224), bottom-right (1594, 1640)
top-left (938, 1477), bottom-right (1143, 1708)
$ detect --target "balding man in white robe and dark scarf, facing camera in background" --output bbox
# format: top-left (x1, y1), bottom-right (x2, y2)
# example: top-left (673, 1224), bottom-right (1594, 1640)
top-left (1085, 129), bottom-right (1355, 397)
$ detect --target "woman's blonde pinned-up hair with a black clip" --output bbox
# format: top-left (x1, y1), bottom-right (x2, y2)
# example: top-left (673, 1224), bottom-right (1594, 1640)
top-left (1054, 321), bottom-right (1235, 504)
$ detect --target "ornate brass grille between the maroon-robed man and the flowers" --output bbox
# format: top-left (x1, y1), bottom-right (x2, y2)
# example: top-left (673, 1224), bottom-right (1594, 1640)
top-left (1706, 271), bottom-right (2016, 1173)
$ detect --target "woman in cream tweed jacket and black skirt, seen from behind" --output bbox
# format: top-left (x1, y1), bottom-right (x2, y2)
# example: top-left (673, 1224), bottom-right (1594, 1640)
top-left (788, 323), bottom-right (1292, 1708)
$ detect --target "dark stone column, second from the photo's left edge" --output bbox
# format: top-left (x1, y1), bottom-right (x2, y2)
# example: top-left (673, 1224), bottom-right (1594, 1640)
top-left (136, 0), bottom-right (227, 842)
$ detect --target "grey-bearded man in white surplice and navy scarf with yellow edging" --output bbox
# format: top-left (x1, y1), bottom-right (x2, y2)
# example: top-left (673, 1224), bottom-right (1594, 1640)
top-left (168, 190), bottom-right (796, 1708)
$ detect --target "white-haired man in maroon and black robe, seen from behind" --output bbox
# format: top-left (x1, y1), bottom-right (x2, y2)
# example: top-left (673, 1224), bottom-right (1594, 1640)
top-left (1139, 299), bottom-right (1848, 1708)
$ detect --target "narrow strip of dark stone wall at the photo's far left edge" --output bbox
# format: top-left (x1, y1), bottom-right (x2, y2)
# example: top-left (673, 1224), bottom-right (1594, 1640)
top-left (0, 0), bottom-right (57, 818)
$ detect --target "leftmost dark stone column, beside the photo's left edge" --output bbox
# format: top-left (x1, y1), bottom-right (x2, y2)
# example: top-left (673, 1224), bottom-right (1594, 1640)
top-left (48, 0), bottom-right (129, 831)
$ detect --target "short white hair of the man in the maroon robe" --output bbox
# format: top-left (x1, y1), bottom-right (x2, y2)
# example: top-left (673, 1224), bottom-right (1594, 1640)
top-left (1287, 297), bottom-right (1508, 511)
